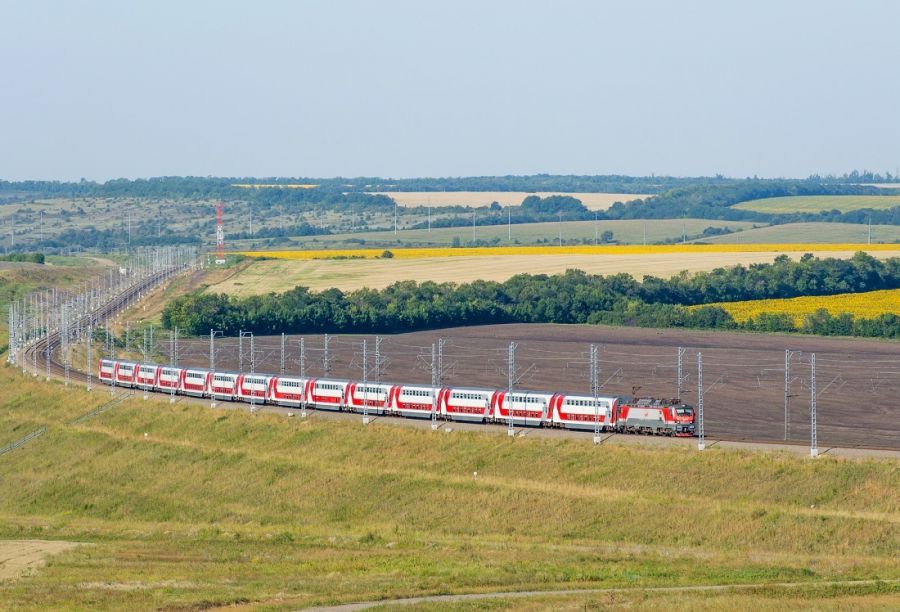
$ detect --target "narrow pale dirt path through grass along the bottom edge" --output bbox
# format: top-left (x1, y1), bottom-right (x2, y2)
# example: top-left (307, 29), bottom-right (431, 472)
top-left (308, 580), bottom-right (900, 612)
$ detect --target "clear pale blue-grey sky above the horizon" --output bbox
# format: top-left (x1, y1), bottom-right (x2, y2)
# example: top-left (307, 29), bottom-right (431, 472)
top-left (0, 0), bottom-right (900, 180)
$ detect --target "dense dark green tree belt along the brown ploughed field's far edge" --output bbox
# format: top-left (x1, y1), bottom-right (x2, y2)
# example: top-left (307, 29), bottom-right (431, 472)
top-left (162, 253), bottom-right (900, 337)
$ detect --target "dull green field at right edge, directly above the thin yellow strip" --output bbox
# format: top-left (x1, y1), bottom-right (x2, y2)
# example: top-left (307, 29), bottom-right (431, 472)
top-left (703, 223), bottom-right (900, 245)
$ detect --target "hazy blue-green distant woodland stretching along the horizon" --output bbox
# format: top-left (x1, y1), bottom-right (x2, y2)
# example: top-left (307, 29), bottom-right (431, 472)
top-left (0, 172), bottom-right (900, 250)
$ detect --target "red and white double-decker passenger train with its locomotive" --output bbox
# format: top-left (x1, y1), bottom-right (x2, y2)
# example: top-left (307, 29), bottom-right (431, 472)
top-left (98, 359), bottom-right (695, 437)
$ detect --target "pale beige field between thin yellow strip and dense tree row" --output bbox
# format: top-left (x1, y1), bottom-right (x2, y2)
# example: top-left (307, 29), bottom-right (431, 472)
top-left (209, 246), bottom-right (900, 296)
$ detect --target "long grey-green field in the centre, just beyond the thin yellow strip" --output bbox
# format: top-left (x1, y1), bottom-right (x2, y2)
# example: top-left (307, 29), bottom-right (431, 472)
top-left (244, 219), bottom-right (754, 249)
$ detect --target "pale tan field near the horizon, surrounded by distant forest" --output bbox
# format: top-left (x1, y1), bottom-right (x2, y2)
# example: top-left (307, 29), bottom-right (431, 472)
top-left (372, 191), bottom-right (651, 210)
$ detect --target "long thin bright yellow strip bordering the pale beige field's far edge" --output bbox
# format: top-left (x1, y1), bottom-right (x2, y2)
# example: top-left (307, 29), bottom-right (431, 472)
top-left (235, 243), bottom-right (900, 260)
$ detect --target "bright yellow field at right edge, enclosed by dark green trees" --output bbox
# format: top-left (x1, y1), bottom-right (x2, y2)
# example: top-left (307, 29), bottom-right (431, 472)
top-left (710, 289), bottom-right (900, 325)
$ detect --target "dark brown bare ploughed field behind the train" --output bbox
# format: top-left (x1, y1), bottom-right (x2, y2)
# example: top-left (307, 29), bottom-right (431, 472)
top-left (179, 324), bottom-right (900, 449)
